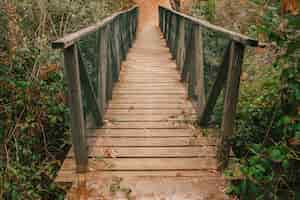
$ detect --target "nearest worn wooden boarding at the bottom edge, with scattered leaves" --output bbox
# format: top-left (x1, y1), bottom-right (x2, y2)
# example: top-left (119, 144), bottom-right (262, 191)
top-left (62, 177), bottom-right (230, 200)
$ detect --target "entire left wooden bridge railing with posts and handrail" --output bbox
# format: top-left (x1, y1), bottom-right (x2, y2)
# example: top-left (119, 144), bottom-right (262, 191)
top-left (52, 7), bottom-right (138, 172)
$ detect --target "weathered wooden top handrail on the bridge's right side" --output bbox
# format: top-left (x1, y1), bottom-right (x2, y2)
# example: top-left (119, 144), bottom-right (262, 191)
top-left (159, 6), bottom-right (259, 47)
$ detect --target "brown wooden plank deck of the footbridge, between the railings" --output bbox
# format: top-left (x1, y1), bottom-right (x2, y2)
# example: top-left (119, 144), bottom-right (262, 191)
top-left (56, 23), bottom-right (227, 200)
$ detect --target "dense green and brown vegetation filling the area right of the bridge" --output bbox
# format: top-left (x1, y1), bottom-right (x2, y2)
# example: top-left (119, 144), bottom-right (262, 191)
top-left (192, 0), bottom-right (300, 200)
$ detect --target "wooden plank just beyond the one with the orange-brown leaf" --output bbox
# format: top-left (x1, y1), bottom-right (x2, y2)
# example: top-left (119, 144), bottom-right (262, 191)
top-left (88, 136), bottom-right (216, 147)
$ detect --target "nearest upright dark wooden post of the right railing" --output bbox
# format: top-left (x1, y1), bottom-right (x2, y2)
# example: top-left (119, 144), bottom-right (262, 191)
top-left (217, 42), bottom-right (245, 169)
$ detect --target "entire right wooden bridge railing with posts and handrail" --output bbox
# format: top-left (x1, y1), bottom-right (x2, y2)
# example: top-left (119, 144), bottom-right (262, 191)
top-left (159, 6), bottom-right (258, 169)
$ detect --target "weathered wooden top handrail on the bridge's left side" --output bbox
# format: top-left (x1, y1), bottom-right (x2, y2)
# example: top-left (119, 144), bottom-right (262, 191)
top-left (52, 6), bottom-right (138, 49)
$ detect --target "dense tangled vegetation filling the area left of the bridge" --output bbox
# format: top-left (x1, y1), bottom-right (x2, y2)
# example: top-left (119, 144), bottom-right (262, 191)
top-left (0, 0), bottom-right (130, 200)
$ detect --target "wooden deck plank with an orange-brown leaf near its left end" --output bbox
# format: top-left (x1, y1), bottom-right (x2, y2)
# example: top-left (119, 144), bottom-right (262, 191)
top-left (67, 146), bottom-right (216, 159)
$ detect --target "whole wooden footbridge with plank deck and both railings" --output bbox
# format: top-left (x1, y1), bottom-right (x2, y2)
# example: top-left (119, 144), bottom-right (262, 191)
top-left (53, 7), bottom-right (258, 200)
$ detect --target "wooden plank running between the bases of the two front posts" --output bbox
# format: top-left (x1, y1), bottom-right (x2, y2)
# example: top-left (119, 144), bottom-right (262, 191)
top-left (63, 158), bottom-right (217, 171)
